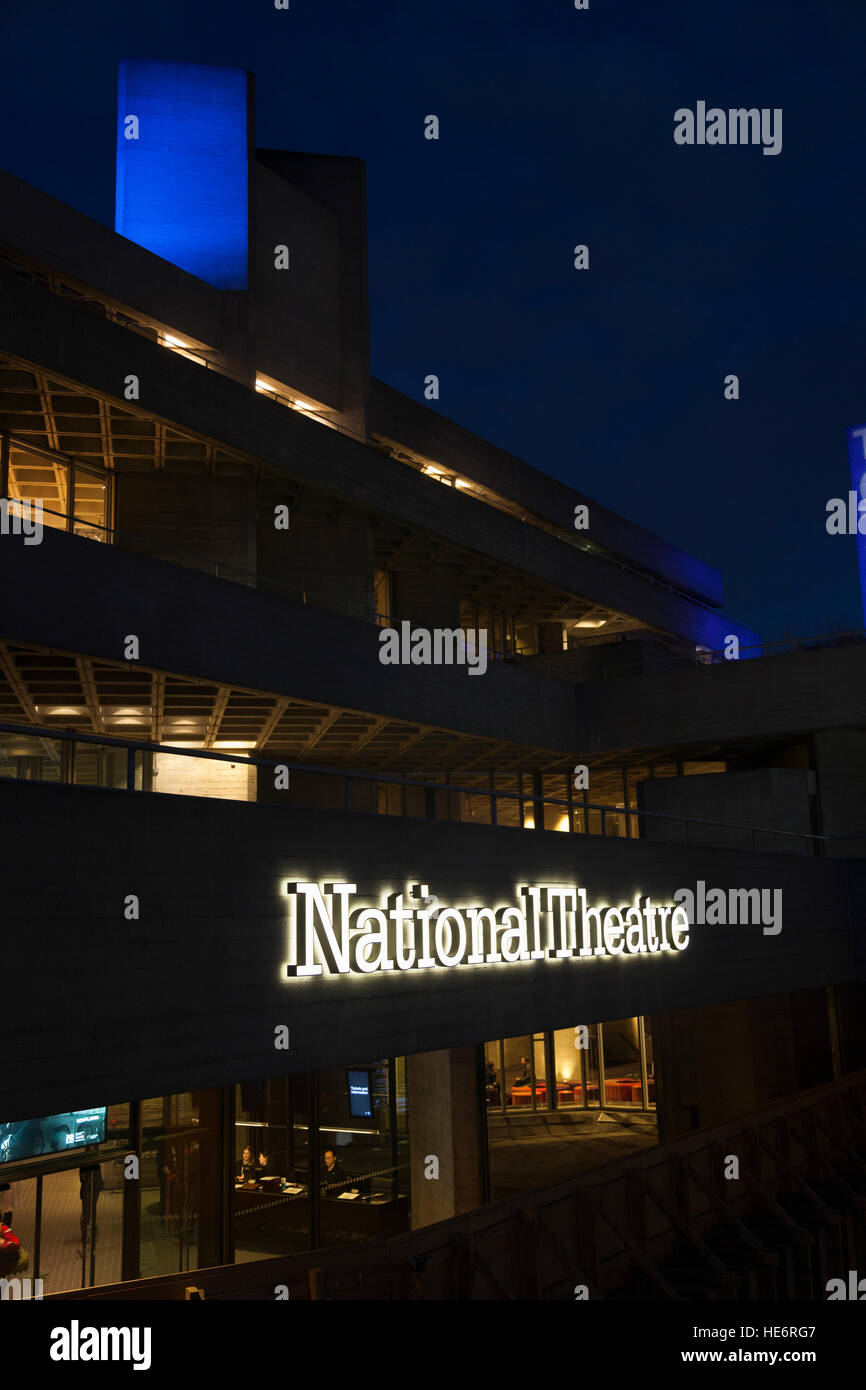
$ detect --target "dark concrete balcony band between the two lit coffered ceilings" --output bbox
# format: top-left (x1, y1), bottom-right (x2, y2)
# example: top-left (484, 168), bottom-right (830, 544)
top-left (0, 522), bottom-right (583, 753)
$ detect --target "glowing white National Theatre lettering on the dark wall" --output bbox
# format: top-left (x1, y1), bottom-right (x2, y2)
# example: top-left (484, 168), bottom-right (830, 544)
top-left (285, 881), bottom-right (689, 977)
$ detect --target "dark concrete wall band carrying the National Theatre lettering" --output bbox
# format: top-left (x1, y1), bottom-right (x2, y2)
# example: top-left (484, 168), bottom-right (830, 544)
top-left (0, 781), bottom-right (865, 1119)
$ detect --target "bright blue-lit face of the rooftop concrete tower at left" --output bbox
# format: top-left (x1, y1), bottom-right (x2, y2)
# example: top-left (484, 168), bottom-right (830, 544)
top-left (114, 60), bottom-right (250, 289)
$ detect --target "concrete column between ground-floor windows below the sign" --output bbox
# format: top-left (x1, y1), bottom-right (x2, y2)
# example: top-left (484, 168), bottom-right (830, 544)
top-left (406, 1047), bottom-right (485, 1229)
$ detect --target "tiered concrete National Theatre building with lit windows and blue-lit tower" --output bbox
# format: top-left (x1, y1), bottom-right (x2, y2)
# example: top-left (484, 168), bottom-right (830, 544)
top-left (0, 63), bottom-right (866, 1295)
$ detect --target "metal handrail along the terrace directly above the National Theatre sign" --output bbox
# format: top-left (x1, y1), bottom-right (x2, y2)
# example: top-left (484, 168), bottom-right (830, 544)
top-left (0, 721), bottom-right (862, 848)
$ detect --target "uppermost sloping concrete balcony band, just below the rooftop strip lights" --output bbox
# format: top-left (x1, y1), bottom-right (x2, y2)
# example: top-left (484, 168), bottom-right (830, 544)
top-left (0, 270), bottom-right (756, 648)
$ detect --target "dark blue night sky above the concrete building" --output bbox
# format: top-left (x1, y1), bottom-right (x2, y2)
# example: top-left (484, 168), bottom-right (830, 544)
top-left (0, 0), bottom-right (866, 638)
